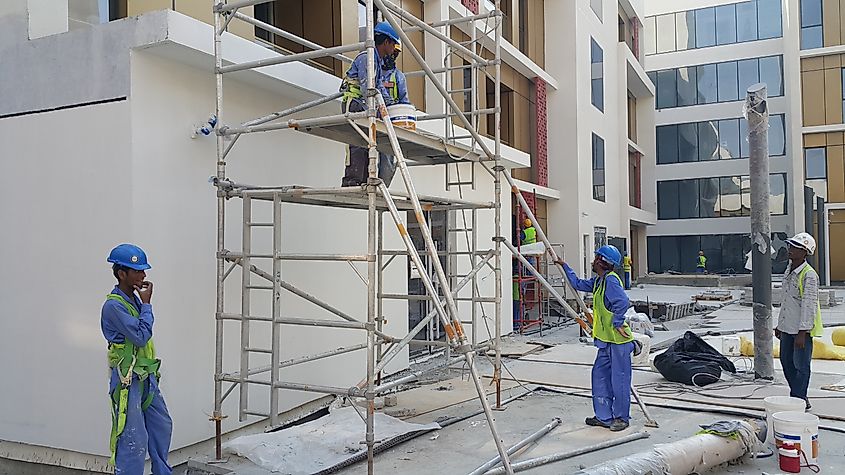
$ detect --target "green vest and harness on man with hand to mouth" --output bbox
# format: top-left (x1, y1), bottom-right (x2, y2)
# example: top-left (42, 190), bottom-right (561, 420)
top-left (106, 294), bottom-right (161, 465)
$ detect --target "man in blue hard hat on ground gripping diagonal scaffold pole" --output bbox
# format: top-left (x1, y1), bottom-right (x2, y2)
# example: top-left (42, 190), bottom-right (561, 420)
top-left (557, 246), bottom-right (634, 432)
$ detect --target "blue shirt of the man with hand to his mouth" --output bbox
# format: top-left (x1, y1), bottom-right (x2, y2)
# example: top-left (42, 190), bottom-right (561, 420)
top-left (100, 286), bottom-right (155, 347)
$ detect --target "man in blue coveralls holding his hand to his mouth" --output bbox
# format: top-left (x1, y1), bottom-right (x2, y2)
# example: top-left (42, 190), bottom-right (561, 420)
top-left (100, 244), bottom-right (173, 475)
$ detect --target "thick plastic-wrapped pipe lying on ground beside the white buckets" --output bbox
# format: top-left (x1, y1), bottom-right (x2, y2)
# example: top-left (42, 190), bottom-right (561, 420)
top-left (576, 421), bottom-right (766, 475)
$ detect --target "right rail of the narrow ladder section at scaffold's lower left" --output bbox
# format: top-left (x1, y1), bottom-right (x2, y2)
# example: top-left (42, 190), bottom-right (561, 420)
top-left (270, 193), bottom-right (282, 427)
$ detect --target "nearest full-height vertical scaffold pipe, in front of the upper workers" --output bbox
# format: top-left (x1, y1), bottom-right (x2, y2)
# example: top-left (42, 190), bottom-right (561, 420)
top-left (366, 0), bottom-right (381, 475)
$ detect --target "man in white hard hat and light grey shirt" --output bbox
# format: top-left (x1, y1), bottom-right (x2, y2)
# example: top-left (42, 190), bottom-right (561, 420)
top-left (775, 233), bottom-right (823, 409)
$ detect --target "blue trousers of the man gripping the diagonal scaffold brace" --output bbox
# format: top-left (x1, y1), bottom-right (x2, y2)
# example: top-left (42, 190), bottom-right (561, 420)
top-left (592, 342), bottom-right (634, 424)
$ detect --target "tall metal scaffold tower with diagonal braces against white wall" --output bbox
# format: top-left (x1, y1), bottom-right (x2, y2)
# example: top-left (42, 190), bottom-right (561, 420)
top-left (212, 0), bottom-right (586, 474)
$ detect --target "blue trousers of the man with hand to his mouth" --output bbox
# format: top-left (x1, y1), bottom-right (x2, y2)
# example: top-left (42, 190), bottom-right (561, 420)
top-left (109, 370), bottom-right (173, 475)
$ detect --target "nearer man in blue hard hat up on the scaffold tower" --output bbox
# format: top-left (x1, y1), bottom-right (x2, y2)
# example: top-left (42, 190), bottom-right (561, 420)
top-left (340, 22), bottom-right (399, 186)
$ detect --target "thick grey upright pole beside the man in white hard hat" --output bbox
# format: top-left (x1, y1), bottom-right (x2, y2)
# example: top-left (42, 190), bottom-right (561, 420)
top-left (745, 84), bottom-right (775, 380)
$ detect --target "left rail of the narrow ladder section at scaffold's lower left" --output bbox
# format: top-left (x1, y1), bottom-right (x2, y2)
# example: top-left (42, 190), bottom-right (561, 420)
top-left (238, 196), bottom-right (252, 422)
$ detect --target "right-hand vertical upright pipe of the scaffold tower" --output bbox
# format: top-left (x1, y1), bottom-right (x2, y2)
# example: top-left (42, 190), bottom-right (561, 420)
top-left (494, 0), bottom-right (503, 408)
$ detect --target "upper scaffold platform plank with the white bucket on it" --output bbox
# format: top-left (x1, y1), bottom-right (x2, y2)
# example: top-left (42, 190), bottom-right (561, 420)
top-left (297, 120), bottom-right (487, 165)
